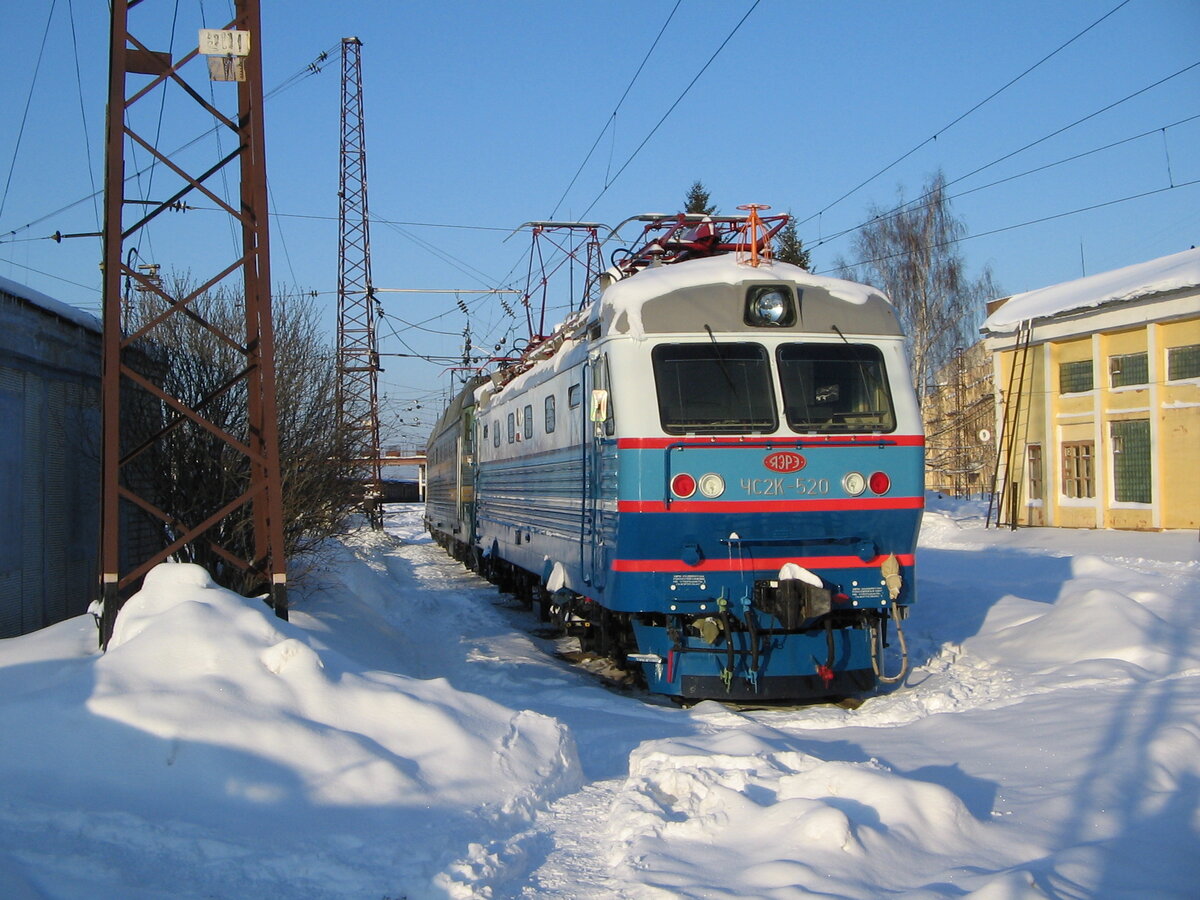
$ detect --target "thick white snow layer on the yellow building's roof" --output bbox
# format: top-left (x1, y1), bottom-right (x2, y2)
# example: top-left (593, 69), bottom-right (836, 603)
top-left (983, 247), bottom-right (1200, 332)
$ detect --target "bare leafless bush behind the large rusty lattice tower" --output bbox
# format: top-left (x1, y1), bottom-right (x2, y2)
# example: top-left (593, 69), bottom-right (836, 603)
top-left (127, 276), bottom-right (361, 593)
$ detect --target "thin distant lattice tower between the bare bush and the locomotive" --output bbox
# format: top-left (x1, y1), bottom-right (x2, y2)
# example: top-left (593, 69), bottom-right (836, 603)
top-left (337, 37), bottom-right (383, 528)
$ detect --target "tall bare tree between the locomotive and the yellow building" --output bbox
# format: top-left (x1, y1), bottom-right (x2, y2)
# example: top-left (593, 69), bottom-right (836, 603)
top-left (834, 172), bottom-right (1000, 397)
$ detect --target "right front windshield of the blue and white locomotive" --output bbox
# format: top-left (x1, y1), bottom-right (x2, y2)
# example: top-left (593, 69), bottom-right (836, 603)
top-left (778, 343), bottom-right (896, 432)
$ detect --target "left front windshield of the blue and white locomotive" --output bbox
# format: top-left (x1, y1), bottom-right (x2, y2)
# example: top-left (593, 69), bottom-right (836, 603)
top-left (650, 341), bottom-right (778, 434)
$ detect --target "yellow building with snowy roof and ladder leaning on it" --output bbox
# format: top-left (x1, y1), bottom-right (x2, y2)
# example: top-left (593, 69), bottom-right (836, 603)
top-left (983, 248), bottom-right (1200, 529)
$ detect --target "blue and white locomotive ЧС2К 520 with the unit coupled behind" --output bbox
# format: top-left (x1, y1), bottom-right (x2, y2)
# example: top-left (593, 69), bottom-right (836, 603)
top-left (426, 211), bottom-right (924, 701)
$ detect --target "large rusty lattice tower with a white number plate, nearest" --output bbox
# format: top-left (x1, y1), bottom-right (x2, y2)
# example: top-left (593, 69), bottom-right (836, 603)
top-left (101, 0), bottom-right (288, 646)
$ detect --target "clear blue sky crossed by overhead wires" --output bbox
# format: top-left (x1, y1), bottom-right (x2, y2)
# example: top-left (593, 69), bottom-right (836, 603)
top-left (0, 0), bottom-right (1200, 437)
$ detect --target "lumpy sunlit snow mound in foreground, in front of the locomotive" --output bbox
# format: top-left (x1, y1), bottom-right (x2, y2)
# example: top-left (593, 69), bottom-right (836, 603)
top-left (610, 704), bottom-right (1043, 900)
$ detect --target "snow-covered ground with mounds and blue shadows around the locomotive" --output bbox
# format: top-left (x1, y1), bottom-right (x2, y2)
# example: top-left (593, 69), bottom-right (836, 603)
top-left (0, 500), bottom-right (1200, 900)
